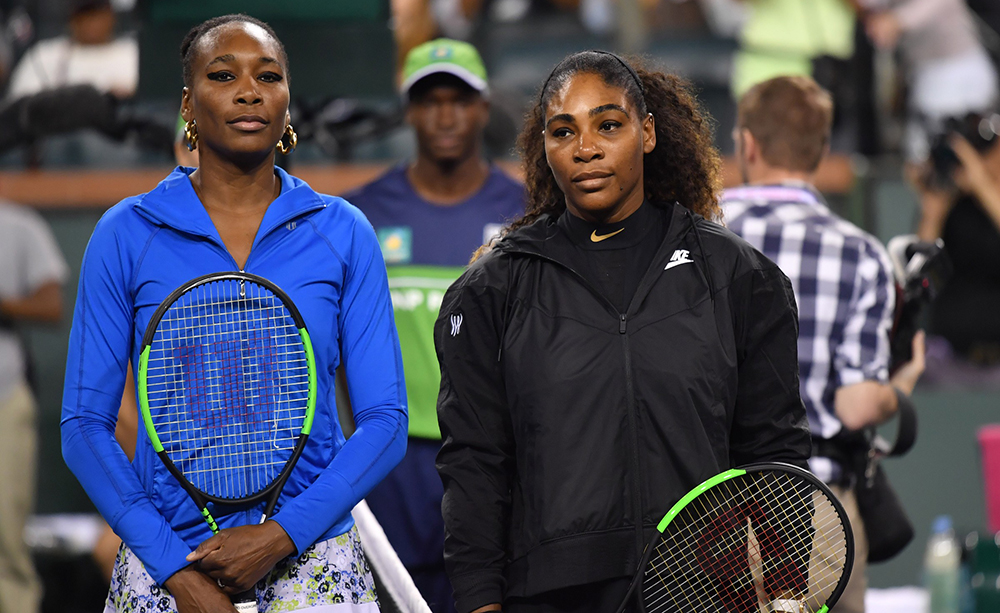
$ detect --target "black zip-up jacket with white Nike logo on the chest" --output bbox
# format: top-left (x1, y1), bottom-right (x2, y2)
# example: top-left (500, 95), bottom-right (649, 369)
top-left (434, 205), bottom-right (810, 613)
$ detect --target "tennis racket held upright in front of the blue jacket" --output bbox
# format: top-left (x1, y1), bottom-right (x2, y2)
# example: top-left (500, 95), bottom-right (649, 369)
top-left (137, 272), bottom-right (316, 613)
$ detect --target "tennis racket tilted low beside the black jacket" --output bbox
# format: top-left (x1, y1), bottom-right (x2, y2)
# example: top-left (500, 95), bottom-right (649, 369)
top-left (618, 463), bottom-right (854, 613)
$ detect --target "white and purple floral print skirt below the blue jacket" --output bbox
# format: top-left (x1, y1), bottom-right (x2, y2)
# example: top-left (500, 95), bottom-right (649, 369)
top-left (104, 528), bottom-right (379, 613)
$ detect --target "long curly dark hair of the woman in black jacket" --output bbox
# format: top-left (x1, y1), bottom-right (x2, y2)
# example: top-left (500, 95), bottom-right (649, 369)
top-left (506, 51), bottom-right (722, 232)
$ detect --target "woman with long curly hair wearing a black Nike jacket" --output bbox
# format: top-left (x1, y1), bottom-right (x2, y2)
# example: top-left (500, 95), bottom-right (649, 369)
top-left (435, 51), bottom-right (810, 613)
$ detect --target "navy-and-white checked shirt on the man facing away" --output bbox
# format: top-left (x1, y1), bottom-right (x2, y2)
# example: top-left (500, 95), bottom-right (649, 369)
top-left (722, 184), bottom-right (896, 481)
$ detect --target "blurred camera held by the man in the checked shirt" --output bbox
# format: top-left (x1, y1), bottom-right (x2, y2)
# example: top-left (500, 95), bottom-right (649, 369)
top-left (887, 234), bottom-right (952, 372)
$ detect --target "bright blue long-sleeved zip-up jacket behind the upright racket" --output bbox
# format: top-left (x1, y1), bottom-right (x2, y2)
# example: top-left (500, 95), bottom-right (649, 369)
top-left (62, 168), bottom-right (407, 584)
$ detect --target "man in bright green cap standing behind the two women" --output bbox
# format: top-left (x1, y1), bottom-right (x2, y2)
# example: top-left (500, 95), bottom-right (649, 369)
top-left (345, 39), bottom-right (524, 612)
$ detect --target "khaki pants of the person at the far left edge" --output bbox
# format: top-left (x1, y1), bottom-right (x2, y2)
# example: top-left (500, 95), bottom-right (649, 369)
top-left (0, 384), bottom-right (42, 613)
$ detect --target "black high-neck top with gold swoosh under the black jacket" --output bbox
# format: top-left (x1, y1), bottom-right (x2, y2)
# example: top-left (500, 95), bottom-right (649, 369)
top-left (558, 202), bottom-right (670, 313)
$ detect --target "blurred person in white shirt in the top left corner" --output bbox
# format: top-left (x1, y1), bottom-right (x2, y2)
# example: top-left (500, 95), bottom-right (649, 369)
top-left (7, 0), bottom-right (139, 99)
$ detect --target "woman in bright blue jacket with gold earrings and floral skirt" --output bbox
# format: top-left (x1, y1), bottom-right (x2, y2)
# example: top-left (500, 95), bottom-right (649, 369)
top-left (62, 15), bottom-right (406, 613)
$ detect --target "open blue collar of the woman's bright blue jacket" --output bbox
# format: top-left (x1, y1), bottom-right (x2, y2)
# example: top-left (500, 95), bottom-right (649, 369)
top-left (136, 166), bottom-right (326, 245)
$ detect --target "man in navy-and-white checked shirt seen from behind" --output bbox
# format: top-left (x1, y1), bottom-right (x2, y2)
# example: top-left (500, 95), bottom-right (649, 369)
top-left (722, 77), bottom-right (924, 613)
